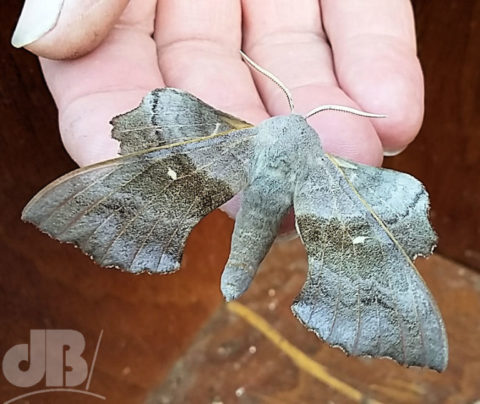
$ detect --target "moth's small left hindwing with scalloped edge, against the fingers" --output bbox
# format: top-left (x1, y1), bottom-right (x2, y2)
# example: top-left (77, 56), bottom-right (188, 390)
top-left (111, 88), bottom-right (252, 155)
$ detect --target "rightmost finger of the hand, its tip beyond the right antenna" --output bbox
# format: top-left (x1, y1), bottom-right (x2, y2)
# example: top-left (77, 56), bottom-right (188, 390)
top-left (321, 0), bottom-right (424, 152)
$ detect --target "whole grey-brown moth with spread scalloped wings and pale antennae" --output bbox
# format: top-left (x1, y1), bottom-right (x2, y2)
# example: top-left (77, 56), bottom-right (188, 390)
top-left (22, 55), bottom-right (448, 371)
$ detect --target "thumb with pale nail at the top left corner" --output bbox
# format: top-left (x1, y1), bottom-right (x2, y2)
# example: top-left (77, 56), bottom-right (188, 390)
top-left (12, 0), bottom-right (128, 59)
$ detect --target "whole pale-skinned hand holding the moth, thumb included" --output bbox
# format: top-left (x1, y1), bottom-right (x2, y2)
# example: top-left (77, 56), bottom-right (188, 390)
top-left (19, 0), bottom-right (424, 218)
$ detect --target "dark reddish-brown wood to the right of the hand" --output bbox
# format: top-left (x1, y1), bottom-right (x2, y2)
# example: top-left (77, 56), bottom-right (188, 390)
top-left (385, 0), bottom-right (480, 270)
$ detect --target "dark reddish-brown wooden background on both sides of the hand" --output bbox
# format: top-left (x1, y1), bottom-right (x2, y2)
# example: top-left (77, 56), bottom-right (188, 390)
top-left (0, 0), bottom-right (480, 403)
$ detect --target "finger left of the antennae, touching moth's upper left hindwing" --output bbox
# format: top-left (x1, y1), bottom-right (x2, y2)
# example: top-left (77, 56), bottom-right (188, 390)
top-left (155, 0), bottom-right (268, 123)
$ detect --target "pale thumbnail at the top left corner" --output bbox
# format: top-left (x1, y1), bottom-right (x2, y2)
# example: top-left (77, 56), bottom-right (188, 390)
top-left (11, 0), bottom-right (64, 48)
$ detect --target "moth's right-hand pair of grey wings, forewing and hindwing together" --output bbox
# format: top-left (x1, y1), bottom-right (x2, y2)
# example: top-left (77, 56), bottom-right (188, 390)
top-left (292, 155), bottom-right (448, 371)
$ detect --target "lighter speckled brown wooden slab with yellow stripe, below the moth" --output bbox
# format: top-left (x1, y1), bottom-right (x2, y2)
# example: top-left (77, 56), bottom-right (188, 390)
top-left (148, 240), bottom-right (480, 404)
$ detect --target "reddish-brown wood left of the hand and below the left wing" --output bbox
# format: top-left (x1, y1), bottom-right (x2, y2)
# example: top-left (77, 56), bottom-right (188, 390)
top-left (0, 1), bottom-right (232, 403)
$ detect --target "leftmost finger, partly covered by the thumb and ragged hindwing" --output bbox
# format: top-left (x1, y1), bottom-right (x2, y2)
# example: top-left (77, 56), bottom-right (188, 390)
top-left (41, 0), bottom-right (163, 165)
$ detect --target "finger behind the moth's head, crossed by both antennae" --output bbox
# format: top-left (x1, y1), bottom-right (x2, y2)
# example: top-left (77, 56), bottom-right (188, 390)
top-left (242, 0), bottom-right (382, 164)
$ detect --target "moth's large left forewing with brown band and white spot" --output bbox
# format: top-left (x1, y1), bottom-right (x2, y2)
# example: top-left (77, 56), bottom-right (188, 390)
top-left (22, 129), bottom-right (255, 273)
